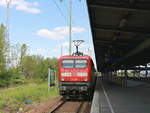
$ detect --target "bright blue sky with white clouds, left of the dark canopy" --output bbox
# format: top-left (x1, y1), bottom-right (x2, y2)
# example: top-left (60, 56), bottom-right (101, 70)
top-left (0, 0), bottom-right (94, 62)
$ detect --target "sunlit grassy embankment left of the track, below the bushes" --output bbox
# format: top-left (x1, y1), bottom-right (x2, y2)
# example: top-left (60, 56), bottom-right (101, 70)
top-left (0, 83), bottom-right (58, 113)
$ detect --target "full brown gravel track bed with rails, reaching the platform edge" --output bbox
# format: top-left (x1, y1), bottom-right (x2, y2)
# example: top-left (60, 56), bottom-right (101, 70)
top-left (26, 97), bottom-right (91, 113)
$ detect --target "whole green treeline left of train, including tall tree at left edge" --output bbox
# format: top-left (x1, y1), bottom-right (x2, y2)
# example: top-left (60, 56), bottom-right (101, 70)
top-left (0, 24), bottom-right (58, 87)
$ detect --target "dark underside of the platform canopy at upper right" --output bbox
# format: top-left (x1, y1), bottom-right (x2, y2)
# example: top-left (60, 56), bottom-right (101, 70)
top-left (87, 0), bottom-right (150, 72)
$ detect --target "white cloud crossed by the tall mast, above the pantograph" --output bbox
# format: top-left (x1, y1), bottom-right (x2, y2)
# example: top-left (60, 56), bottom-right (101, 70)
top-left (37, 27), bottom-right (86, 40)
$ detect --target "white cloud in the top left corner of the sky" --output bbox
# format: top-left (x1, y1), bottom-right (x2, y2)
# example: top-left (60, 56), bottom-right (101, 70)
top-left (0, 0), bottom-right (41, 14)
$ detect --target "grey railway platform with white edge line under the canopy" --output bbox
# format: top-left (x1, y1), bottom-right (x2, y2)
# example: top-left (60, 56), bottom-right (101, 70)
top-left (91, 78), bottom-right (150, 113)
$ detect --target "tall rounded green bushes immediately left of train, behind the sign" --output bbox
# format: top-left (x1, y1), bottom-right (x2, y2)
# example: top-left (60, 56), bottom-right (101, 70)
top-left (22, 55), bottom-right (58, 80)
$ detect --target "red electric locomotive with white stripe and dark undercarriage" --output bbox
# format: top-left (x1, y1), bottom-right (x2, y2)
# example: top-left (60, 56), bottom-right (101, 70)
top-left (59, 56), bottom-right (96, 97)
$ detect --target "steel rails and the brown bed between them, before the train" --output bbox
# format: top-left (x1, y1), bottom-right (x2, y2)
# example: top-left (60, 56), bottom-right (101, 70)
top-left (49, 101), bottom-right (88, 113)
